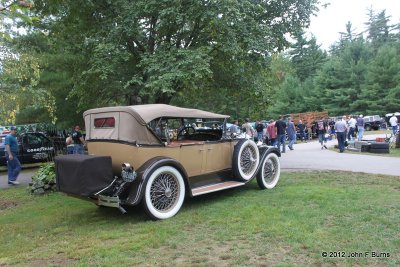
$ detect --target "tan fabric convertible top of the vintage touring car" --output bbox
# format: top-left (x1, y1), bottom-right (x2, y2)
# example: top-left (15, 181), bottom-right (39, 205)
top-left (83, 104), bottom-right (229, 144)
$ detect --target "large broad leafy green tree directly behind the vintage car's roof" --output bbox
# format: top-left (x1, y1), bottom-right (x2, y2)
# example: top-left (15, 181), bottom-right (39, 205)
top-left (26, 0), bottom-right (317, 112)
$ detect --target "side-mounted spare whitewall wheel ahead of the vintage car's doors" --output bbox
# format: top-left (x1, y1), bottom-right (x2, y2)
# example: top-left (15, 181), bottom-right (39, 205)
top-left (232, 139), bottom-right (260, 182)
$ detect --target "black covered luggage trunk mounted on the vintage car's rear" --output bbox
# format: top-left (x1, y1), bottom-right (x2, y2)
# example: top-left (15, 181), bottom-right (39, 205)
top-left (55, 155), bottom-right (114, 197)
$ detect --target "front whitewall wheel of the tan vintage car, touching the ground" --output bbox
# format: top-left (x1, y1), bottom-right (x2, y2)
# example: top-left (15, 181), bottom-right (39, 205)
top-left (257, 153), bottom-right (281, 189)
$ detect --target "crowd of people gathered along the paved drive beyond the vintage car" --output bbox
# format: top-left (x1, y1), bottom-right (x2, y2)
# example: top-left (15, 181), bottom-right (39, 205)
top-left (230, 115), bottom-right (398, 153)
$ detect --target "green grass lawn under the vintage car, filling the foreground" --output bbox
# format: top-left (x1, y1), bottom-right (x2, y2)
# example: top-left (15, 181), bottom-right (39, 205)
top-left (0, 171), bottom-right (400, 266)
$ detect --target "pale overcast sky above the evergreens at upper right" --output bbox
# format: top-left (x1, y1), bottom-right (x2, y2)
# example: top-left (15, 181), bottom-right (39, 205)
top-left (309, 0), bottom-right (400, 49)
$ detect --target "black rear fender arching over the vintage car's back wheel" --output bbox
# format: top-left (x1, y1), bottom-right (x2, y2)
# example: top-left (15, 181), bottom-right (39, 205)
top-left (124, 157), bottom-right (188, 206)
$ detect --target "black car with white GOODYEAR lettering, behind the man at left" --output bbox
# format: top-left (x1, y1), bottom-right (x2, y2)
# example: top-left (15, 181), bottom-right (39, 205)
top-left (0, 132), bottom-right (55, 167)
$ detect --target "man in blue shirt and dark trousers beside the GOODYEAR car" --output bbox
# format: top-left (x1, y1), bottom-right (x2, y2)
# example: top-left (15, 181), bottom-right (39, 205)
top-left (4, 126), bottom-right (21, 185)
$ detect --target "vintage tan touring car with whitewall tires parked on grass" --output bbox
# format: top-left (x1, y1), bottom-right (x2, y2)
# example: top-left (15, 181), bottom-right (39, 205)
top-left (55, 104), bottom-right (280, 219)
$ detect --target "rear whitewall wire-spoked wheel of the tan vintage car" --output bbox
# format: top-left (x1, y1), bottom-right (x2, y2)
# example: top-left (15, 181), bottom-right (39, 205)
top-left (143, 166), bottom-right (185, 220)
